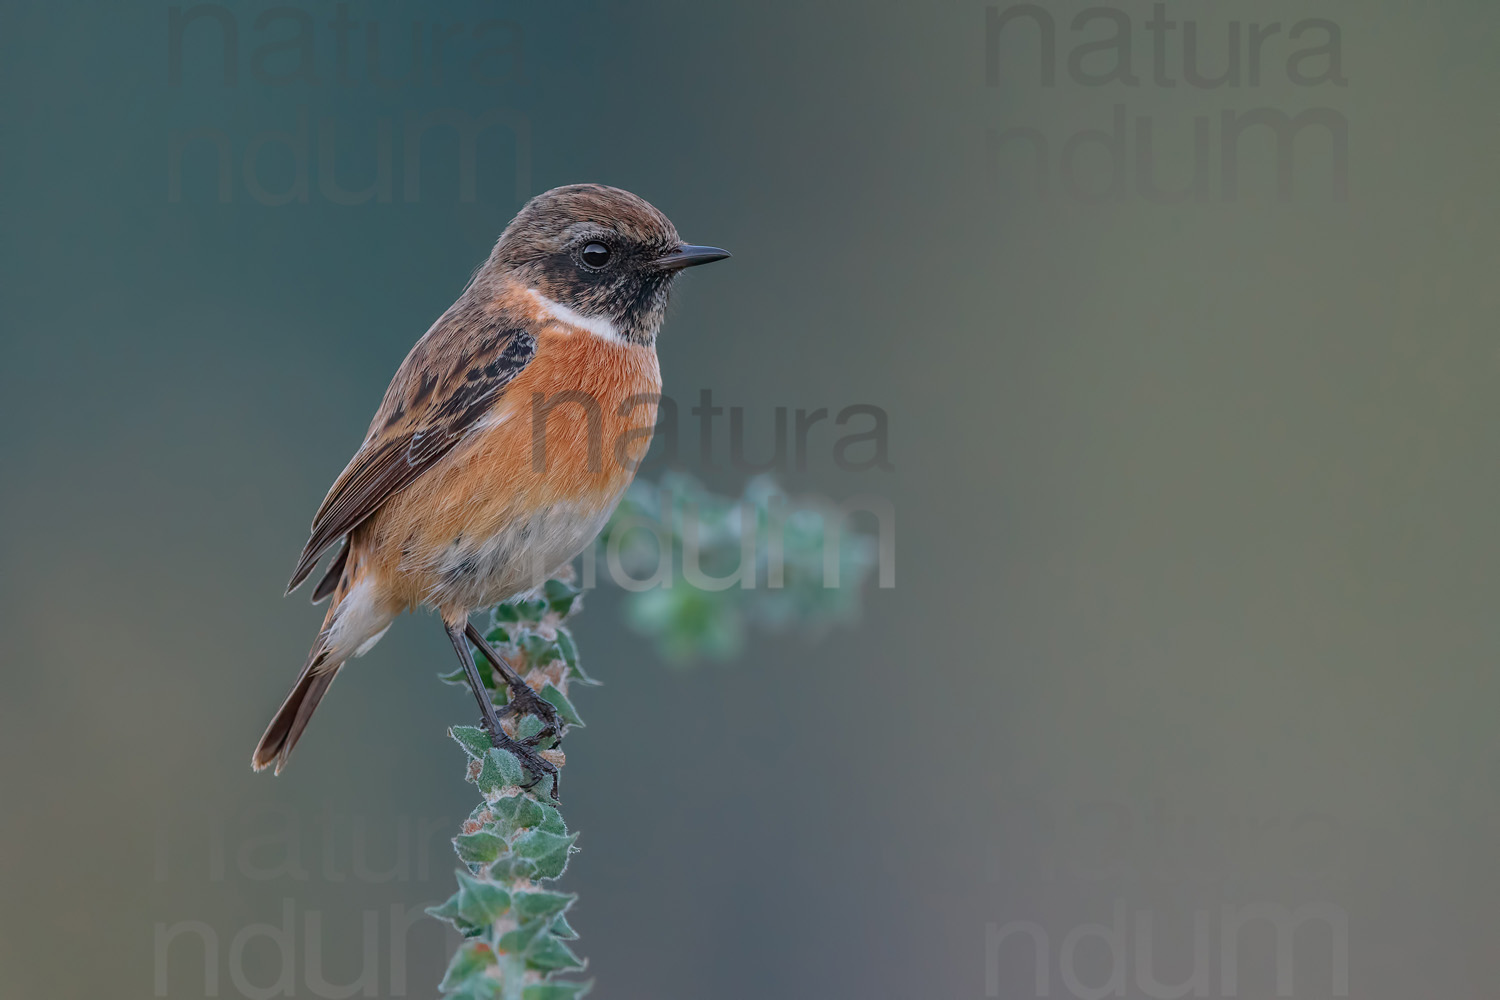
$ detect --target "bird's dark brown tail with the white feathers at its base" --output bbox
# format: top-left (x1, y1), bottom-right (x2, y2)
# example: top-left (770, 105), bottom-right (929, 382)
top-left (251, 554), bottom-right (395, 774)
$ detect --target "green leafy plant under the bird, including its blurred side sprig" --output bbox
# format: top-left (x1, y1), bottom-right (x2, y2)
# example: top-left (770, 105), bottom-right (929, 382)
top-left (428, 474), bottom-right (876, 1000)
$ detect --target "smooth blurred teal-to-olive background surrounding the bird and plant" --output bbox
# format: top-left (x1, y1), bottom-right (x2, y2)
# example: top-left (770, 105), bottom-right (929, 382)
top-left (0, 0), bottom-right (1500, 1000)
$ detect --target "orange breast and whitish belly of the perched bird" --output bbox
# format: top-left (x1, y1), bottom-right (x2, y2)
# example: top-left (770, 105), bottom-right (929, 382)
top-left (365, 320), bottom-right (662, 619)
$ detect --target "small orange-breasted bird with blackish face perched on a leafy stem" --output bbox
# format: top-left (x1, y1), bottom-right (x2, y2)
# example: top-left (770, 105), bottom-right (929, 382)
top-left (252, 184), bottom-right (729, 775)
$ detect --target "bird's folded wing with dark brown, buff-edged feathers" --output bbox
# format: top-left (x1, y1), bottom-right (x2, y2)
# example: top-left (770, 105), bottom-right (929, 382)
top-left (287, 313), bottom-right (537, 594)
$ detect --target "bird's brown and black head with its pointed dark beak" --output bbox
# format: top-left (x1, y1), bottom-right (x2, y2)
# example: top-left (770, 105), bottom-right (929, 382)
top-left (492, 184), bottom-right (729, 343)
